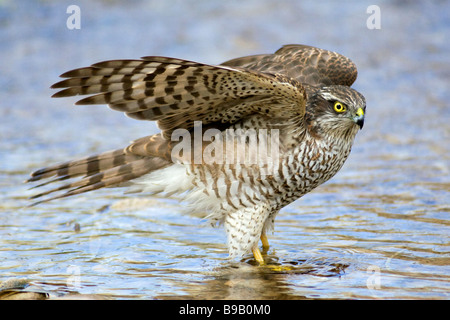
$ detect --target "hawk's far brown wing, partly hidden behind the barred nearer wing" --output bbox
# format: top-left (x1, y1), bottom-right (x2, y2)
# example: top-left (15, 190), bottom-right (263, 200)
top-left (222, 44), bottom-right (358, 87)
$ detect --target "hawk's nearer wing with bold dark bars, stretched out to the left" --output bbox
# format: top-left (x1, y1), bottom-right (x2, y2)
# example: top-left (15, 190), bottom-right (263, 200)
top-left (52, 57), bottom-right (306, 138)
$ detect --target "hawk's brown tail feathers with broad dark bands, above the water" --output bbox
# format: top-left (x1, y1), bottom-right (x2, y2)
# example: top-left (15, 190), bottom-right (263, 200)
top-left (26, 149), bottom-right (170, 205)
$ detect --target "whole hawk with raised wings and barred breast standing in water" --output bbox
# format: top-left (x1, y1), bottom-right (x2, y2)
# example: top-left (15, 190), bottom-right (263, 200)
top-left (28, 45), bottom-right (366, 265)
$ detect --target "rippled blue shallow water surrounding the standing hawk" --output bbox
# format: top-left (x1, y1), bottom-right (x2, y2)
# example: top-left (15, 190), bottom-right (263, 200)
top-left (0, 0), bottom-right (450, 299)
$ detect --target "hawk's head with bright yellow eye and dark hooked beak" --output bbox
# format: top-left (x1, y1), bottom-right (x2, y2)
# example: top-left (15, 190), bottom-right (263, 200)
top-left (306, 85), bottom-right (366, 136)
